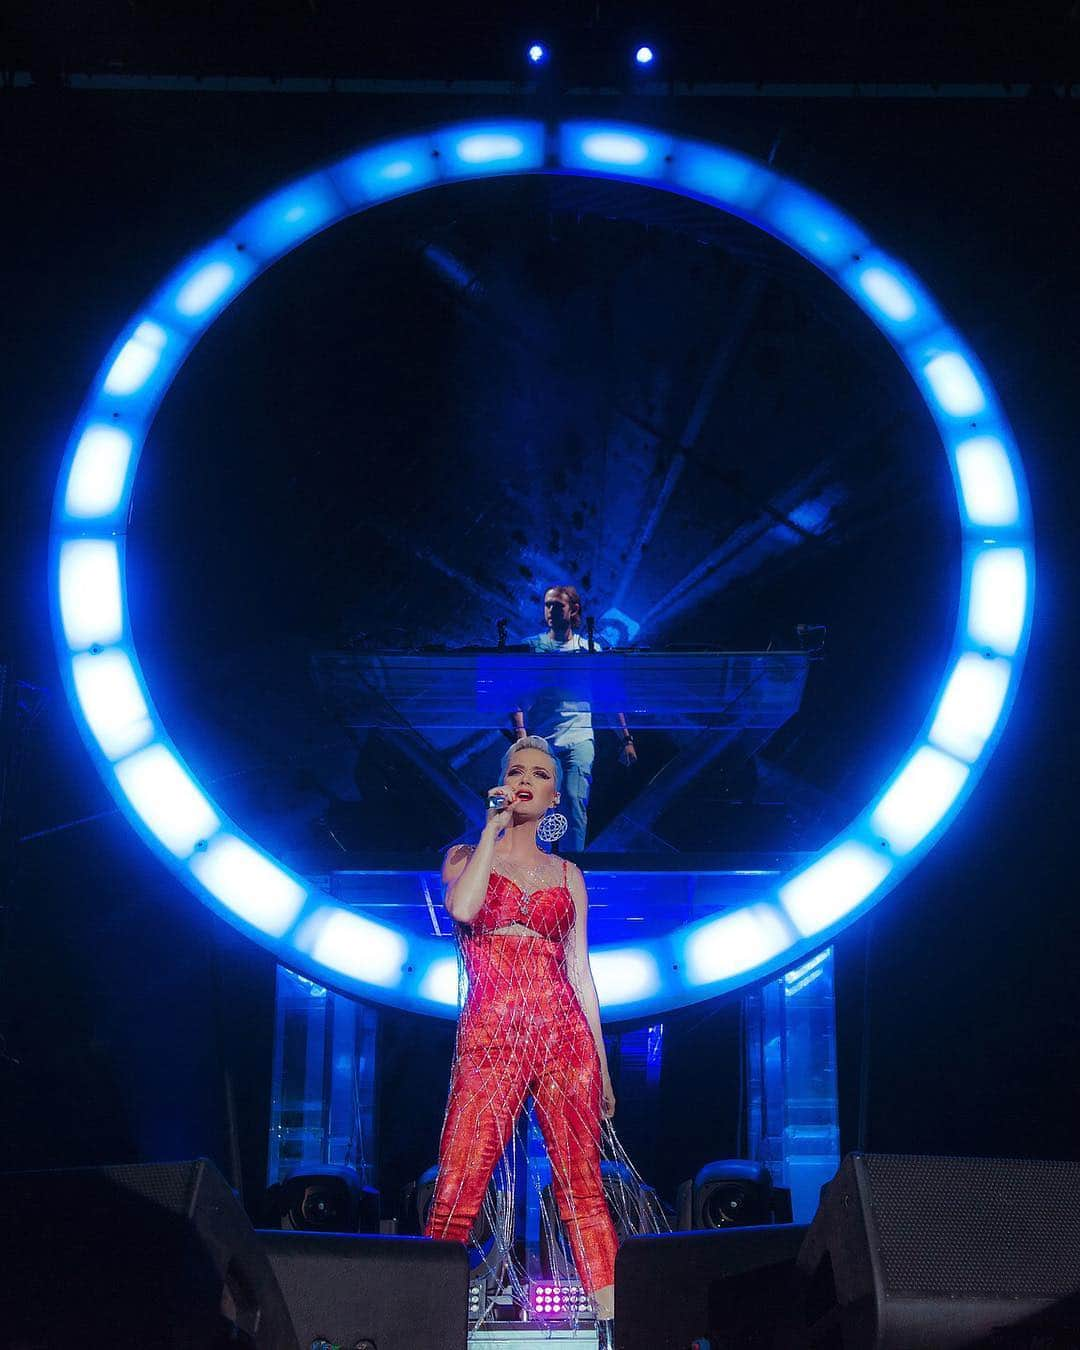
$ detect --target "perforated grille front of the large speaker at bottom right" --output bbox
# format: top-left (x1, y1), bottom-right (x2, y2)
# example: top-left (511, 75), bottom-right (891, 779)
top-left (860, 1154), bottom-right (1080, 1299)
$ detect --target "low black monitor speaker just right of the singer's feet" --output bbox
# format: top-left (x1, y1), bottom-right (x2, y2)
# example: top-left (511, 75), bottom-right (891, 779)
top-left (616, 1223), bottom-right (806, 1350)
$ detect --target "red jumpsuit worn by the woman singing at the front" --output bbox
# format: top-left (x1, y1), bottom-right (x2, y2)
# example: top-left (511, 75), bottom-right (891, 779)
top-left (425, 863), bottom-right (617, 1293)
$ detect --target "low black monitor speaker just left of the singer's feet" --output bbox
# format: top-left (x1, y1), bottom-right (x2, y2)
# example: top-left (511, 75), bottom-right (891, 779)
top-left (259, 1229), bottom-right (468, 1350)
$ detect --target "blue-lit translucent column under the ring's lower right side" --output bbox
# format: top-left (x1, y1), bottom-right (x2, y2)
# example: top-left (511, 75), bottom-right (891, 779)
top-left (744, 946), bottom-right (840, 1223)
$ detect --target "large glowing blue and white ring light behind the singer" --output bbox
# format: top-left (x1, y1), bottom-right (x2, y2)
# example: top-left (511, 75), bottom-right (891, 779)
top-left (50, 120), bottom-right (1034, 1017)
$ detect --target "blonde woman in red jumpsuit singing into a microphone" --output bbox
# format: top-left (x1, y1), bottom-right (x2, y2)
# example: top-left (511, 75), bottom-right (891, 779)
top-left (425, 736), bottom-right (617, 1322)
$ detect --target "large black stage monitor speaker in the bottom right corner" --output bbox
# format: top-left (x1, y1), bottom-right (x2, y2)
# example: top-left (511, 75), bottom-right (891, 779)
top-left (792, 1153), bottom-right (1080, 1350)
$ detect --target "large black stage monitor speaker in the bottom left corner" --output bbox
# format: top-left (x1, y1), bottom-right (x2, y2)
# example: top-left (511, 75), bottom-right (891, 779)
top-left (0, 1158), bottom-right (297, 1350)
